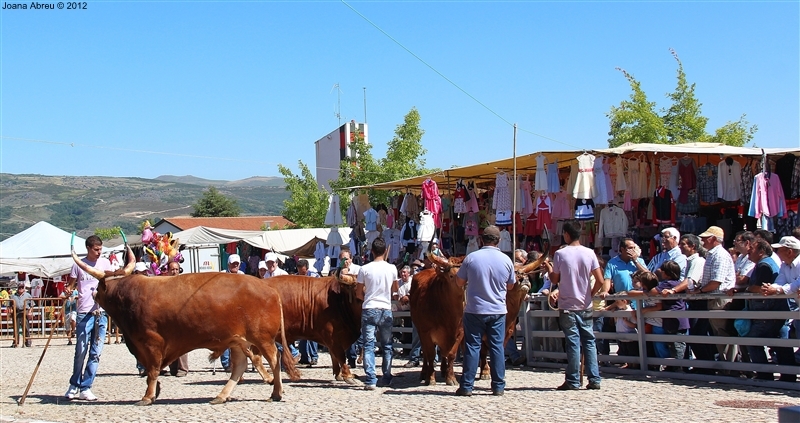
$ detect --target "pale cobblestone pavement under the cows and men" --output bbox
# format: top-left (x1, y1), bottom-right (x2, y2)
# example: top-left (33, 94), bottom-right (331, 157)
top-left (0, 340), bottom-right (800, 423)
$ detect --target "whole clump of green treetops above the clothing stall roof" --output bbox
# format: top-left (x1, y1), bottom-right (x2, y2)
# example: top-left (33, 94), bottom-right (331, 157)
top-left (606, 49), bottom-right (758, 147)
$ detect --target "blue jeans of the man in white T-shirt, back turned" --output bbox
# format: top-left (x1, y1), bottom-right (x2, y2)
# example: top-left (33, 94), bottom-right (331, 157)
top-left (361, 308), bottom-right (393, 385)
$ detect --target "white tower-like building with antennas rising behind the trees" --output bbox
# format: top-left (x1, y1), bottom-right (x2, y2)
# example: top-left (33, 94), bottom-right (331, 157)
top-left (314, 120), bottom-right (369, 192)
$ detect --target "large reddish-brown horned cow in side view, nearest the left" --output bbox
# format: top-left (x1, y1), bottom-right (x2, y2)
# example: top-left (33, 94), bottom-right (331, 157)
top-left (72, 248), bottom-right (300, 405)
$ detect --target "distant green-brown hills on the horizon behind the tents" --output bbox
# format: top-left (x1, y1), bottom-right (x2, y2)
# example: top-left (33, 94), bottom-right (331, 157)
top-left (0, 173), bottom-right (289, 241)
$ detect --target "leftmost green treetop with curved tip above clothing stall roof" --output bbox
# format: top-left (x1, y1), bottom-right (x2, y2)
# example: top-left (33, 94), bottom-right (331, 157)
top-left (606, 68), bottom-right (667, 148)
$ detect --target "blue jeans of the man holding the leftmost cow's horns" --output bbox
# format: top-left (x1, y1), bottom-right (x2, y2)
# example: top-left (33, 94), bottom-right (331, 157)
top-left (69, 313), bottom-right (108, 391)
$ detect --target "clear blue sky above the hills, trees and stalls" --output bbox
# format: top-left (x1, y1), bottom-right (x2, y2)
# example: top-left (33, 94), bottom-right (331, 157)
top-left (0, 0), bottom-right (800, 180)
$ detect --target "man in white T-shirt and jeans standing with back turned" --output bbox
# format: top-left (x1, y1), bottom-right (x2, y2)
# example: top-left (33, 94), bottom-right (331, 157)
top-left (356, 237), bottom-right (397, 391)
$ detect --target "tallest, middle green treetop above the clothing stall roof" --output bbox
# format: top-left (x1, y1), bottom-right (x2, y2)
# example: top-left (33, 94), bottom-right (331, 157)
top-left (664, 49), bottom-right (708, 144)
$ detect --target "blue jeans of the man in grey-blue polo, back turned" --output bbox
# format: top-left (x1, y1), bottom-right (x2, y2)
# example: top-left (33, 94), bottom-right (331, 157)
top-left (459, 313), bottom-right (506, 392)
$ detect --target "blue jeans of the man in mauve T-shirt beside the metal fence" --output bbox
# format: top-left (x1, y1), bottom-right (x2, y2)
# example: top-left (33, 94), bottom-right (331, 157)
top-left (558, 310), bottom-right (600, 388)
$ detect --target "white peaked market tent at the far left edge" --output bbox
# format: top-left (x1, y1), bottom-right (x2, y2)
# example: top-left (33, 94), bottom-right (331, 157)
top-left (0, 222), bottom-right (108, 278)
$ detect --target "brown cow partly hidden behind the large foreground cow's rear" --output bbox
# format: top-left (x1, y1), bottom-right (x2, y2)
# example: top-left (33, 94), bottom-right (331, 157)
top-left (255, 276), bottom-right (363, 383)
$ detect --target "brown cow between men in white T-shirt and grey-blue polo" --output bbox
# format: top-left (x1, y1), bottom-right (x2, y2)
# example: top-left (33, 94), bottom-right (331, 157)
top-left (409, 257), bottom-right (464, 385)
